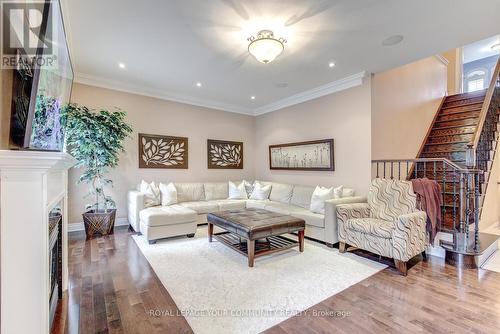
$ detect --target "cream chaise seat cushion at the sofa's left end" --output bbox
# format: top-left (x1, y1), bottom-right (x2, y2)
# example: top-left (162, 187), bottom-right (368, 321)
top-left (139, 204), bottom-right (197, 226)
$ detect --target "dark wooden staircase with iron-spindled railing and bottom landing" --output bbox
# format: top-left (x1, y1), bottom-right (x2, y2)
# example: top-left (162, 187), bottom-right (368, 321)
top-left (372, 59), bottom-right (500, 267)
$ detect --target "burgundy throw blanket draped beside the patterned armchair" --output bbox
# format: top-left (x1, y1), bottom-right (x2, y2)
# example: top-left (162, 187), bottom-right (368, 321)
top-left (411, 178), bottom-right (443, 244)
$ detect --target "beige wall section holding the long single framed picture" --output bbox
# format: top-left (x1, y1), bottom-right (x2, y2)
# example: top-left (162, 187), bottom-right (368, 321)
top-left (255, 78), bottom-right (371, 194)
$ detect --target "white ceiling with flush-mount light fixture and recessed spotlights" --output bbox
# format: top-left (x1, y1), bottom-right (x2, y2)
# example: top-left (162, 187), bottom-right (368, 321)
top-left (62, 0), bottom-right (500, 114)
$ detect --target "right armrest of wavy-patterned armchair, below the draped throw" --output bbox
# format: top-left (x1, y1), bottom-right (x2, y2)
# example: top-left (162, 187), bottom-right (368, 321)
top-left (392, 211), bottom-right (427, 262)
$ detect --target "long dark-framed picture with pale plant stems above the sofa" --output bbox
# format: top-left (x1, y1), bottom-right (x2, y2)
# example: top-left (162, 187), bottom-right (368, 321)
top-left (269, 139), bottom-right (335, 171)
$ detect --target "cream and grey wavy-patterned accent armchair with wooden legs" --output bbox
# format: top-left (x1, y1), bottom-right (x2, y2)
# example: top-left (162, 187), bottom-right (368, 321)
top-left (337, 179), bottom-right (427, 275)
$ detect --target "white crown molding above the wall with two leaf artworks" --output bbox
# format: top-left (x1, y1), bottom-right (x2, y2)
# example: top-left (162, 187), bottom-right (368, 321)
top-left (74, 73), bottom-right (253, 115)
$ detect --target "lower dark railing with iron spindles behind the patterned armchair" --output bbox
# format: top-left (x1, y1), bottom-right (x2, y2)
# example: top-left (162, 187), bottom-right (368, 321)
top-left (372, 158), bottom-right (483, 248)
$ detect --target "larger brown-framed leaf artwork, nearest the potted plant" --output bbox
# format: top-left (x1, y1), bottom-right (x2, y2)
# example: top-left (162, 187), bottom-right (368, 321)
top-left (139, 133), bottom-right (188, 169)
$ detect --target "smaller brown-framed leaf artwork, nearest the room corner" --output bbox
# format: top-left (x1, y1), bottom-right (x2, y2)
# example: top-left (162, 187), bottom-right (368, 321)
top-left (207, 139), bottom-right (243, 169)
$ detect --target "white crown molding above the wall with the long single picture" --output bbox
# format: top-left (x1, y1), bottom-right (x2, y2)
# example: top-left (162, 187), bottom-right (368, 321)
top-left (253, 71), bottom-right (367, 116)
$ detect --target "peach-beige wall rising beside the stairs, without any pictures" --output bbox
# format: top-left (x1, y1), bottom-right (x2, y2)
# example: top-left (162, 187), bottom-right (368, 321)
top-left (371, 57), bottom-right (447, 159)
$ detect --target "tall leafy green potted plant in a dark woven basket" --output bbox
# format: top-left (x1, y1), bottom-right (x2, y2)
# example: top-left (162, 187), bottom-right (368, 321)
top-left (63, 104), bottom-right (132, 239)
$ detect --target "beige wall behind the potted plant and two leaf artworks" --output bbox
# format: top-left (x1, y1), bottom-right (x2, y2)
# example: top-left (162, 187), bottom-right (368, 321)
top-left (69, 84), bottom-right (255, 223)
